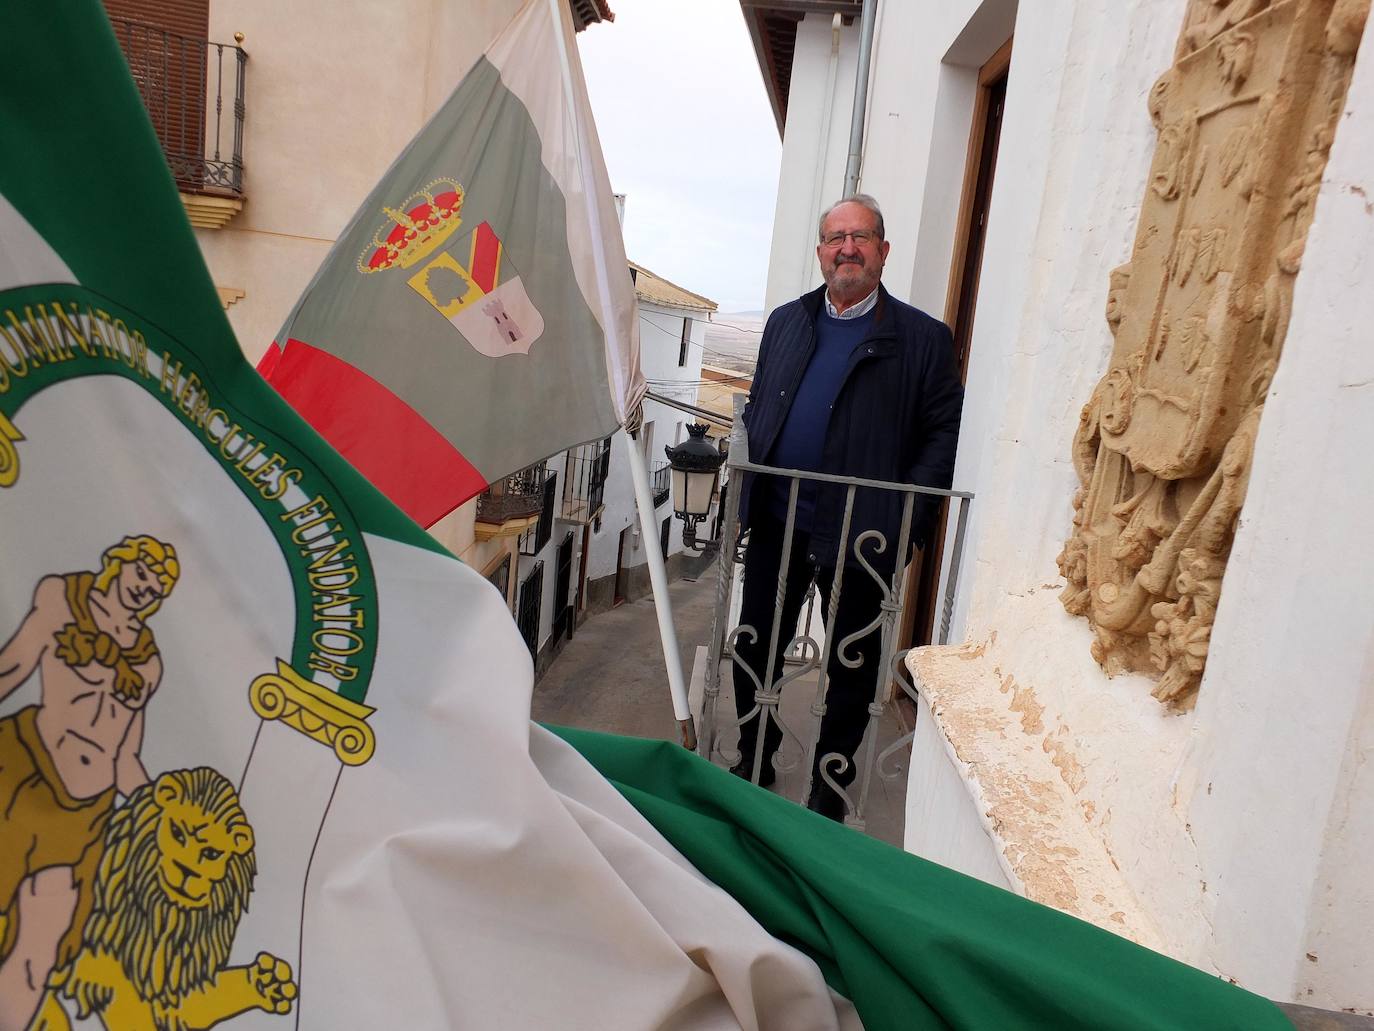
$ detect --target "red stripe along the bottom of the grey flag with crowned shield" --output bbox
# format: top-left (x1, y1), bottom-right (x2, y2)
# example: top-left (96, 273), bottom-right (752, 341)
top-left (258, 340), bottom-right (486, 526)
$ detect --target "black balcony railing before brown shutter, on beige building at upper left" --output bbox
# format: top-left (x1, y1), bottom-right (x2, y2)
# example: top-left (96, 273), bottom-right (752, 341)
top-left (114, 19), bottom-right (249, 198)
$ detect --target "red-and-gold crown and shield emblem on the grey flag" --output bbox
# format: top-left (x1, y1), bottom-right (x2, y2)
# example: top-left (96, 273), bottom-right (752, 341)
top-left (357, 179), bottom-right (544, 357)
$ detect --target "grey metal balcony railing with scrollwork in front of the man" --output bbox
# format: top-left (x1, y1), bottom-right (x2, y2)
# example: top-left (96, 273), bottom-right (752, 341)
top-left (698, 399), bottom-right (973, 829)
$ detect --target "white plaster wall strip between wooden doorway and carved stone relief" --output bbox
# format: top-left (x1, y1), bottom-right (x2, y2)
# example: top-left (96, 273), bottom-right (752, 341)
top-left (947, 0), bottom-right (1184, 641)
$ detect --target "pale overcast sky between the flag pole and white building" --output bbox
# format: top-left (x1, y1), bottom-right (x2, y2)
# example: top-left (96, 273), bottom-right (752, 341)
top-left (577, 0), bottom-right (782, 312)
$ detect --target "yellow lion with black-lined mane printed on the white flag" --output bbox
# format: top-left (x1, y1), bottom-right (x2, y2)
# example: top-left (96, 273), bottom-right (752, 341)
top-left (30, 767), bottom-right (297, 1031)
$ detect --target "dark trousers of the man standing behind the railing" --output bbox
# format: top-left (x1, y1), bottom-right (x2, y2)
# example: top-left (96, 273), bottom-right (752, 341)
top-left (734, 514), bottom-right (882, 789)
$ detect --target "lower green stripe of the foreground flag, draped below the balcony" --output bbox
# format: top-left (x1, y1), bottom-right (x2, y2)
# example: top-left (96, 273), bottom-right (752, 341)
top-left (551, 727), bottom-right (1292, 1031)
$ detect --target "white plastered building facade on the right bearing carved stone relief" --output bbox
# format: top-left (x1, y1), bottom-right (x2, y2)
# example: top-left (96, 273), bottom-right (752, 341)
top-left (745, 0), bottom-right (1374, 1012)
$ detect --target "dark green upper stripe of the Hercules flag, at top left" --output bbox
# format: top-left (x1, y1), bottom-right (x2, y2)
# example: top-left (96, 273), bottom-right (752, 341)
top-left (0, 0), bottom-right (447, 554)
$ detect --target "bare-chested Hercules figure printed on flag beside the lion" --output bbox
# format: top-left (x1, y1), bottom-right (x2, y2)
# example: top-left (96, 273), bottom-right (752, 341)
top-left (0, 536), bottom-right (180, 1031)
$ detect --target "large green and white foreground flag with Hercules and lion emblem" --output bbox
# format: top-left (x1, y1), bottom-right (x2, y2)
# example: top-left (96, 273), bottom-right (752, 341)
top-left (0, 0), bottom-right (1287, 1031)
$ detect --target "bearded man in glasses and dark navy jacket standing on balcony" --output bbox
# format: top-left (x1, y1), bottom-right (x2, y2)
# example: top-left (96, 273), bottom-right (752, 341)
top-left (732, 194), bottom-right (963, 819)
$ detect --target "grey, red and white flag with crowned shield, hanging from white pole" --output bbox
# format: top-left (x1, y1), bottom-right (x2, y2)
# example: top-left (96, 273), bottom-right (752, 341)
top-left (260, 0), bottom-right (644, 526)
